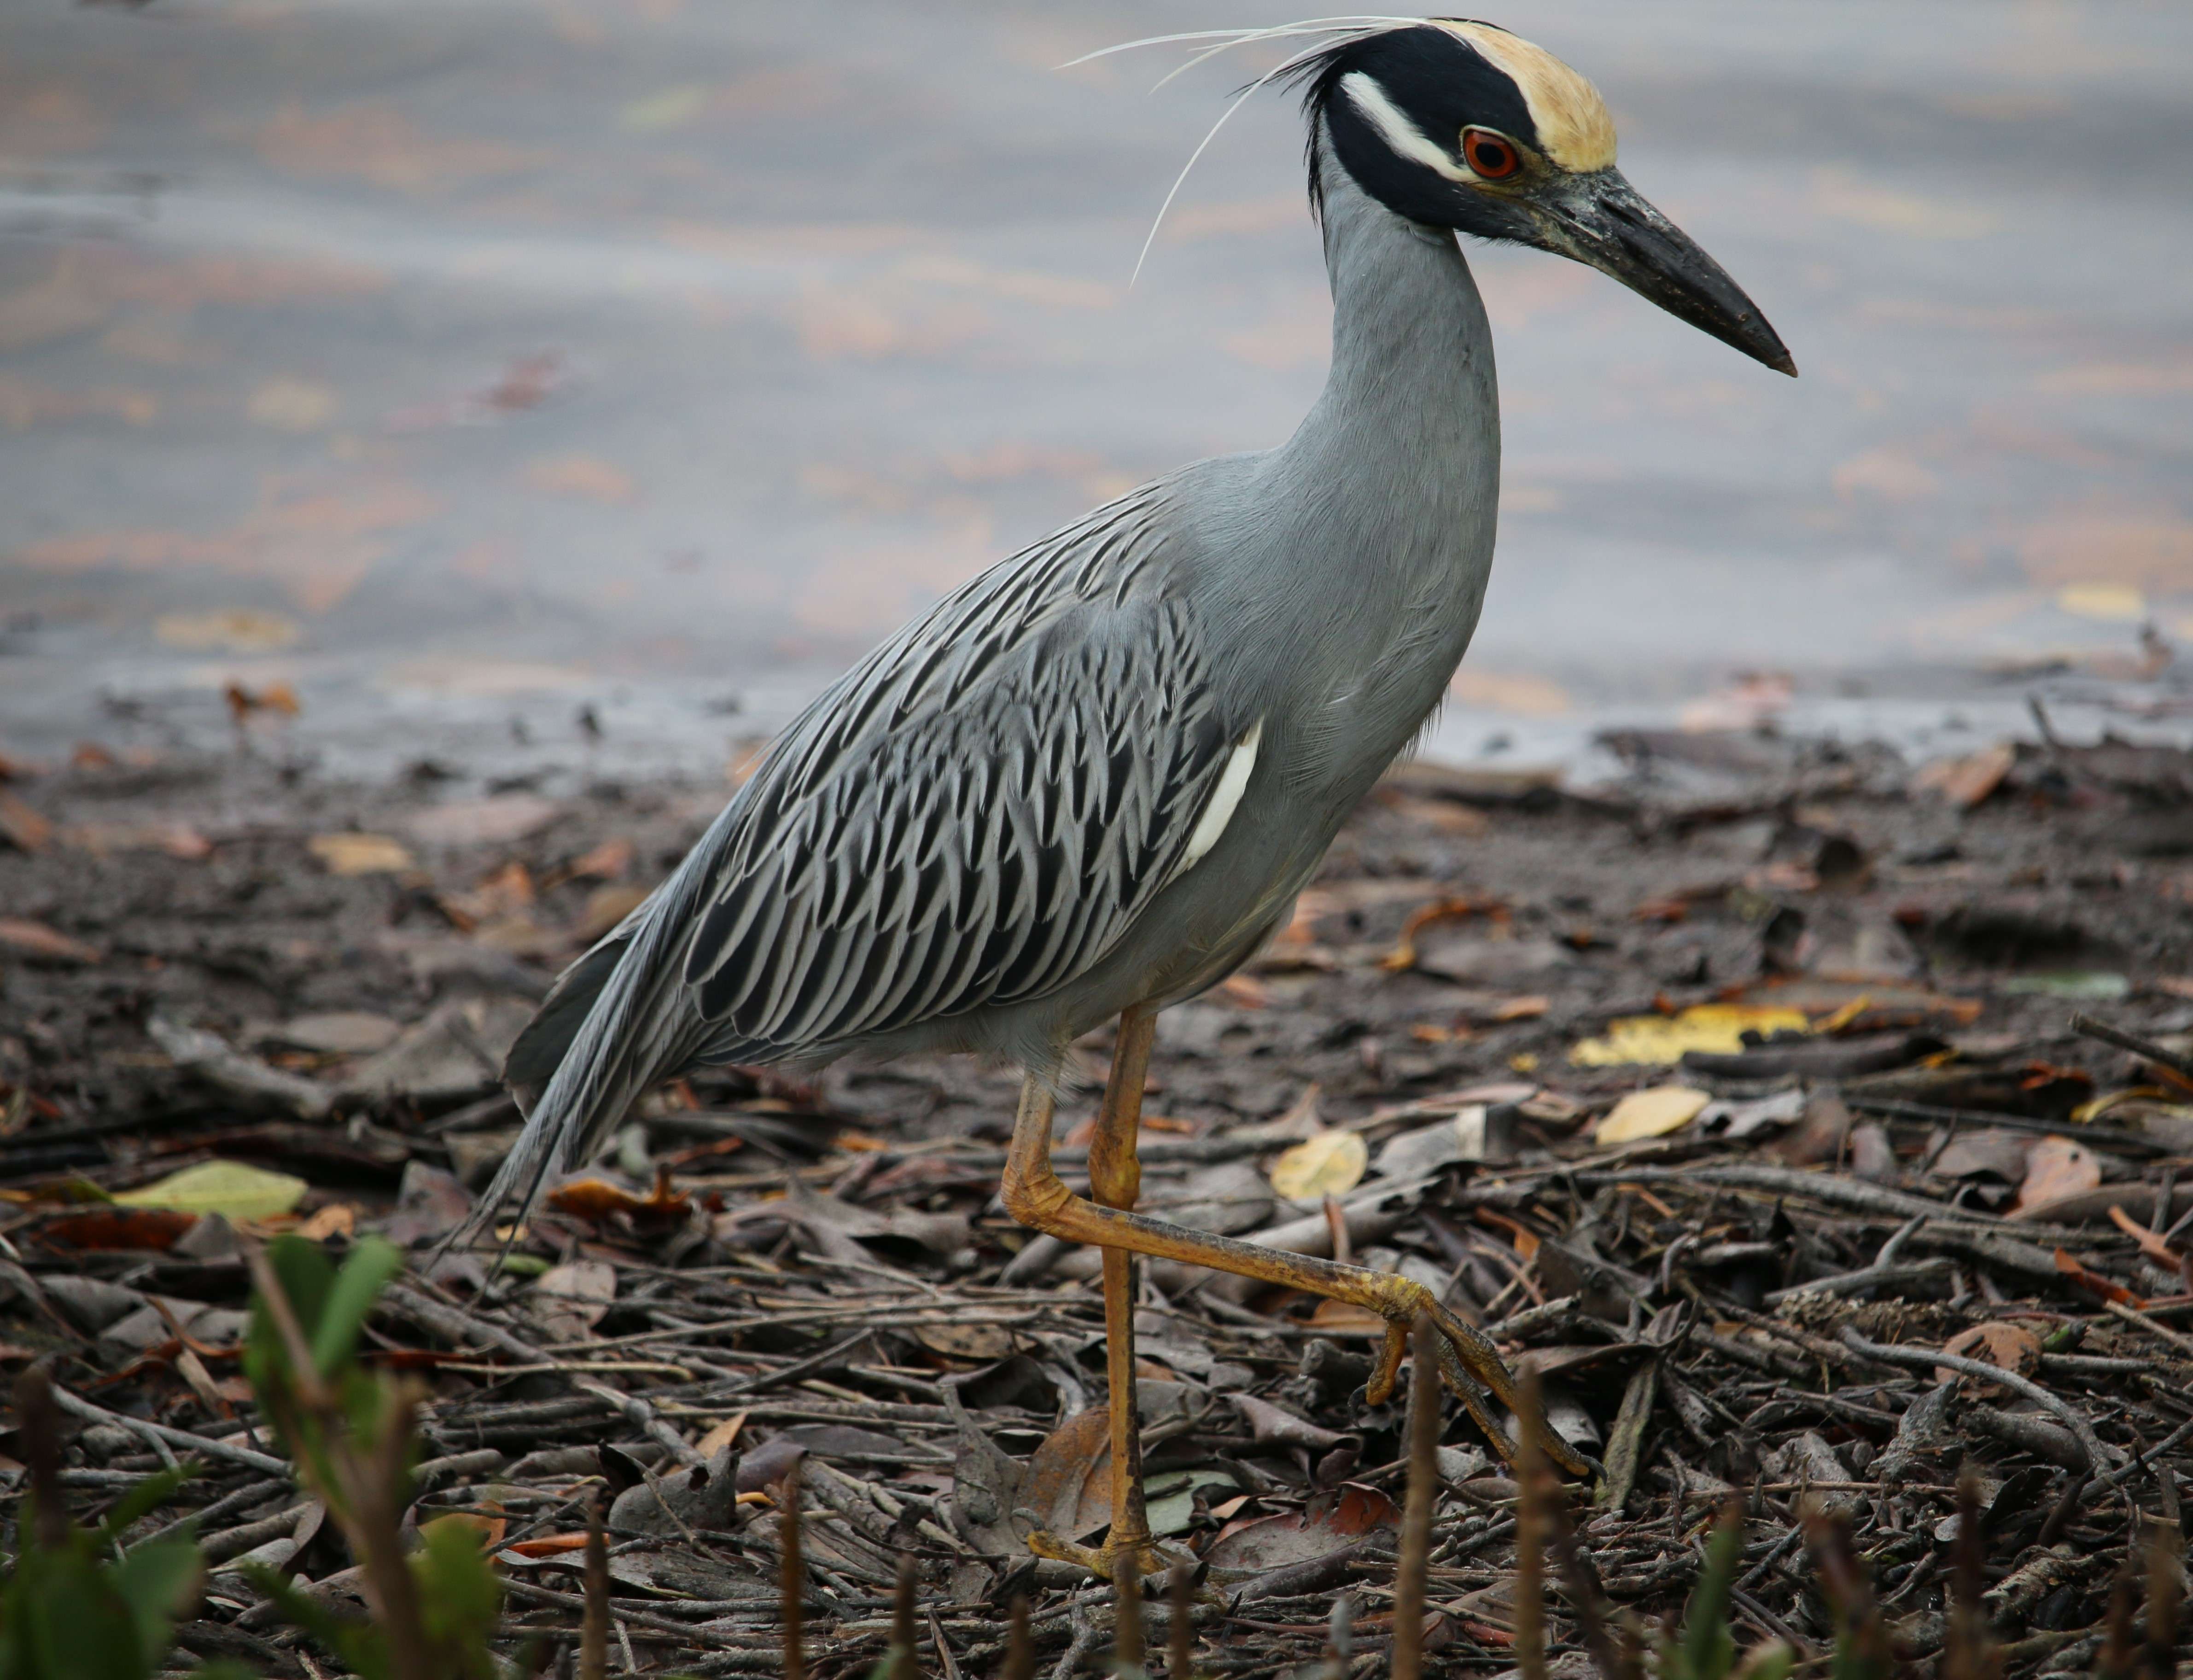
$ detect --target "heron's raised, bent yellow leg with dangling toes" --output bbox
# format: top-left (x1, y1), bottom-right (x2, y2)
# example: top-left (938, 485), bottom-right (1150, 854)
top-left (1002, 1070), bottom-right (1597, 1509)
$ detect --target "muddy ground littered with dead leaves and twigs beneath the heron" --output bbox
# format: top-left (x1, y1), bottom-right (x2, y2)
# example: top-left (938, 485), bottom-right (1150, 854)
top-left (0, 737), bottom-right (2193, 1675)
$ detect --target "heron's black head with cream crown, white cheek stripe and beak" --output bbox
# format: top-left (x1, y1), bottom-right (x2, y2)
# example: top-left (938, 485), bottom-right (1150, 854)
top-left (1305, 18), bottom-right (1796, 375)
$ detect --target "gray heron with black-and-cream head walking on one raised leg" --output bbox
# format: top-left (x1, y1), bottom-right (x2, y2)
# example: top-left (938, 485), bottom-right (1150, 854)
top-left (458, 18), bottom-right (1796, 1573)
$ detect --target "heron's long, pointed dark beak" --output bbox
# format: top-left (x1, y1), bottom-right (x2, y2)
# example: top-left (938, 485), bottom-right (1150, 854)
top-left (1531, 169), bottom-right (1796, 379)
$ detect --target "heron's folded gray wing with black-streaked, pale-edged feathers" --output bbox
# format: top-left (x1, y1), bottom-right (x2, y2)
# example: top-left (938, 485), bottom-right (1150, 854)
top-left (684, 489), bottom-right (1232, 1059)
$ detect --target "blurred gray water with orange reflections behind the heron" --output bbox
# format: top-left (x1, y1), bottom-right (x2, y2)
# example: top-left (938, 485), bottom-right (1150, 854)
top-left (0, 0), bottom-right (2193, 772)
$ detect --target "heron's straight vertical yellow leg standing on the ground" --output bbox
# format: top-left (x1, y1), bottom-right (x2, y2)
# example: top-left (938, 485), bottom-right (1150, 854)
top-left (1028, 1009), bottom-right (1160, 1579)
